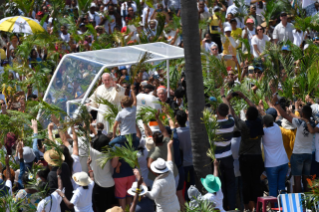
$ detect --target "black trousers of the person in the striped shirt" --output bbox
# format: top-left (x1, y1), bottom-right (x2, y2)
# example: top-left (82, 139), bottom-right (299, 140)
top-left (217, 155), bottom-right (236, 210)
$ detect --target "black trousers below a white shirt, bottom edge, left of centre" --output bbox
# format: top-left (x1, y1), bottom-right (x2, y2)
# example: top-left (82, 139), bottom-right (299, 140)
top-left (92, 183), bottom-right (115, 212)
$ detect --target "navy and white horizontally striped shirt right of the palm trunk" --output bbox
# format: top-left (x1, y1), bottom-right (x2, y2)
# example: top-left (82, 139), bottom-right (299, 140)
top-left (214, 115), bottom-right (235, 159)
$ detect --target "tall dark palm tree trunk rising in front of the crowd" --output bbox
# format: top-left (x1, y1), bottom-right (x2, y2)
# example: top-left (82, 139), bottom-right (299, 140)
top-left (181, 0), bottom-right (212, 188)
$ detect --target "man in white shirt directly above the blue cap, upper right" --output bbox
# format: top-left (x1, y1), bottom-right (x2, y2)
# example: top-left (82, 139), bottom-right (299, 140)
top-left (273, 12), bottom-right (294, 43)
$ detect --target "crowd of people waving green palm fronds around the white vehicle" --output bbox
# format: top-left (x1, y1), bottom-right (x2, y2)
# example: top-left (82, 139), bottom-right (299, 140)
top-left (0, 0), bottom-right (319, 212)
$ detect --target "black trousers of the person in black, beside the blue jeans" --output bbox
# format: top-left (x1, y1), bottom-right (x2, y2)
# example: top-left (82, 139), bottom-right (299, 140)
top-left (239, 155), bottom-right (264, 204)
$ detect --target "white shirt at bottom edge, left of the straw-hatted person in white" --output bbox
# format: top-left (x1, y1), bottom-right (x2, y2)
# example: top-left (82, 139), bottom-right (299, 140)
top-left (37, 191), bottom-right (62, 212)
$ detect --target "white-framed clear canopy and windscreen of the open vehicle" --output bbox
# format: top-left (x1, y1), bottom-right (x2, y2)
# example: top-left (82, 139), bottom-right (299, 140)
top-left (44, 42), bottom-right (184, 116)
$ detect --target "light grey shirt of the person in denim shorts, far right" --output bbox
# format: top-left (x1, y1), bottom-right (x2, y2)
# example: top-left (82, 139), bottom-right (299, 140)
top-left (292, 118), bottom-right (313, 154)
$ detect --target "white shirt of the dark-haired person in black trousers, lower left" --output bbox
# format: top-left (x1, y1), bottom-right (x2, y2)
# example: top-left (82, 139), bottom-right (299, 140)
top-left (90, 148), bottom-right (114, 188)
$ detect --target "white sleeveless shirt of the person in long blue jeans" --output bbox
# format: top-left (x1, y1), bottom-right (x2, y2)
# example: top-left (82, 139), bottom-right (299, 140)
top-left (262, 123), bottom-right (289, 167)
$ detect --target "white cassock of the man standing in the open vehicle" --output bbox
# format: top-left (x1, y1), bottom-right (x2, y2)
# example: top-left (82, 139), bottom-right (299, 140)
top-left (90, 84), bottom-right (125, 132)
